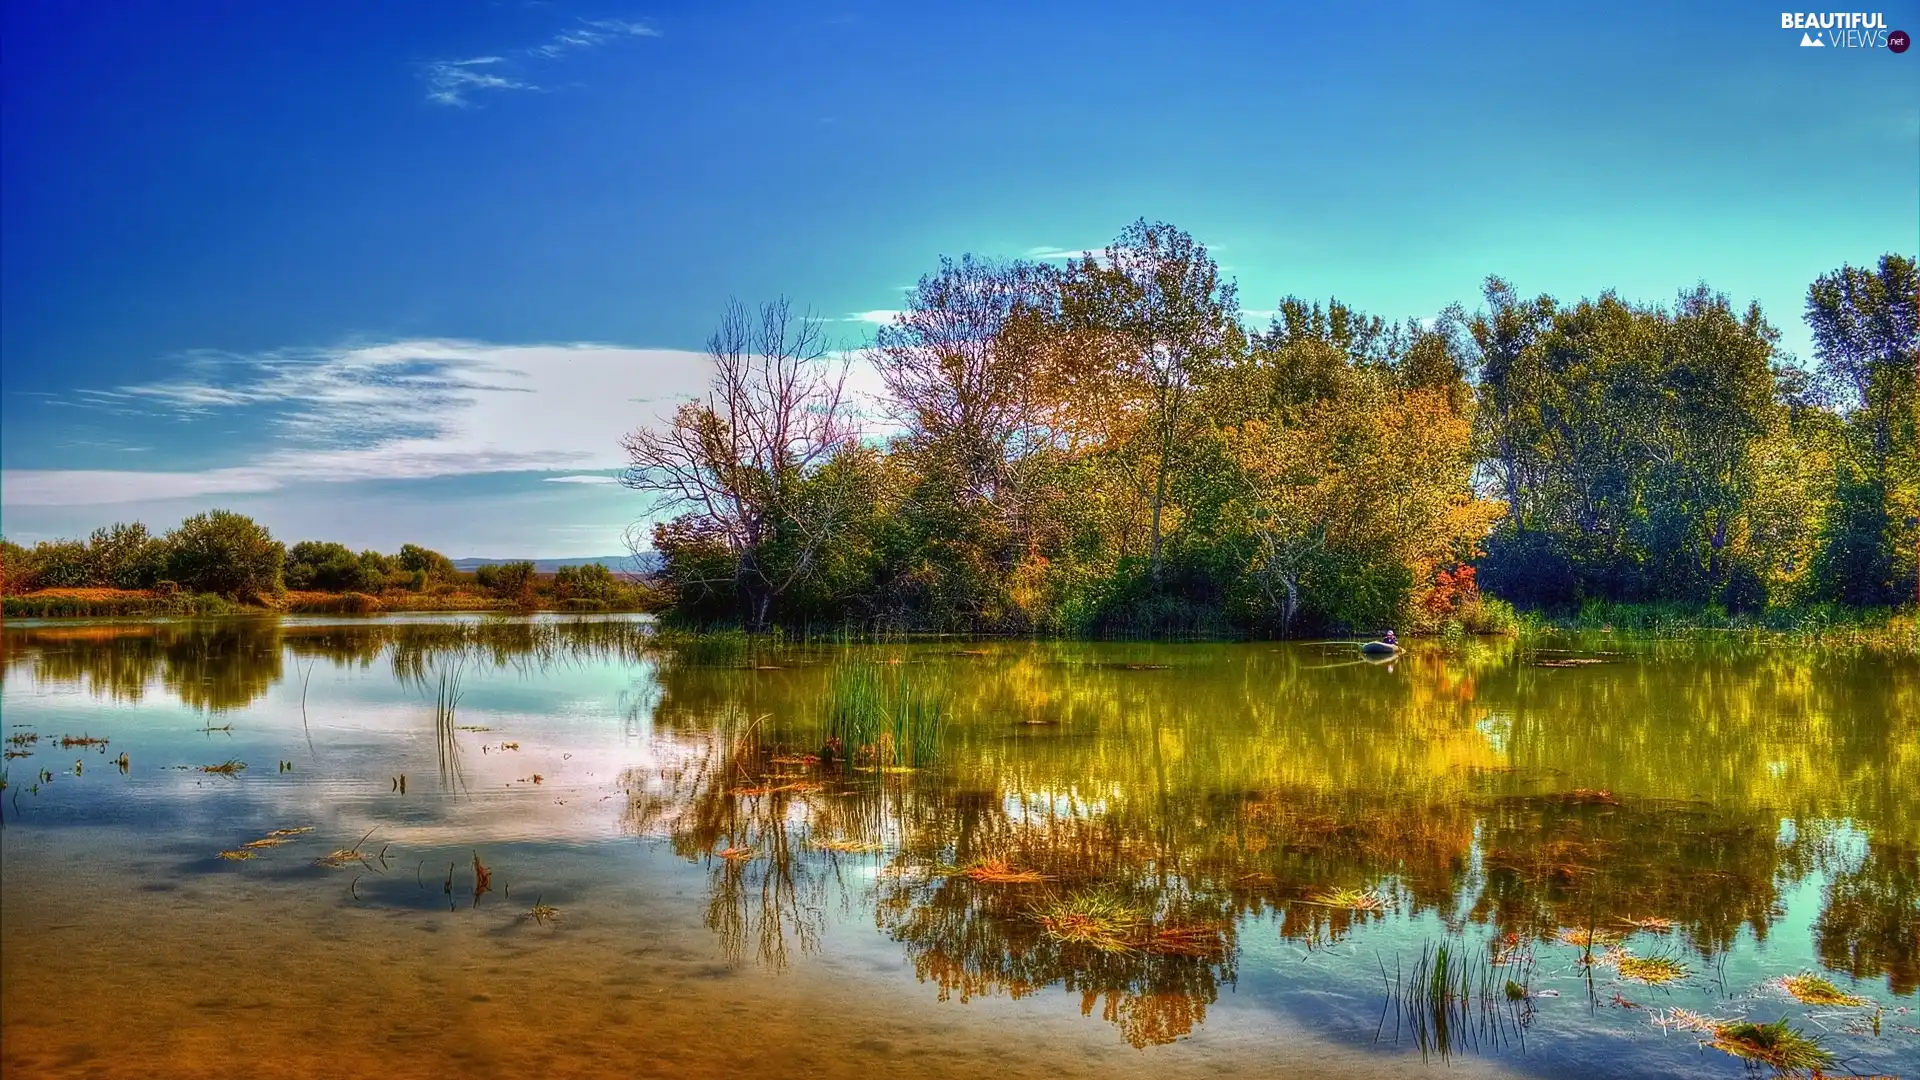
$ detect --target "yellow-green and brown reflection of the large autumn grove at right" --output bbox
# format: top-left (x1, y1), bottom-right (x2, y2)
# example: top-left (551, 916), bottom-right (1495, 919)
top-left (629, 646), bottom-right (1920, 1042)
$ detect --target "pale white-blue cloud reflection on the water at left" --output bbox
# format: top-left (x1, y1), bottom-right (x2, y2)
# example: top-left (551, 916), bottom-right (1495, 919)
top-left (0, 667), bottom-right (675, 859)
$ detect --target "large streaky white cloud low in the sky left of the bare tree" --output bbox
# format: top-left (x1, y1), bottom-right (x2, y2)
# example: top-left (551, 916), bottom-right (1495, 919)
top-left (0, 340), bottom-right (712, 507)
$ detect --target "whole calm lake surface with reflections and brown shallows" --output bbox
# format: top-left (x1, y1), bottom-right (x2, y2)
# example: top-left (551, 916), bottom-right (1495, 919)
top-left (0, 617), bottom-right (1920, 1076)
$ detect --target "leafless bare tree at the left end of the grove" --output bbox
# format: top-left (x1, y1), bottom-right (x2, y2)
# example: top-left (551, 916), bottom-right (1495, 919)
top-left (620, 298), bottom-right (860, 630)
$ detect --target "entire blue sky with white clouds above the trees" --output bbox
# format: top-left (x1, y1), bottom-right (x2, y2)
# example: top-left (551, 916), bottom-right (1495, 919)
top-left (0, 0), bottom-right (1920, 555)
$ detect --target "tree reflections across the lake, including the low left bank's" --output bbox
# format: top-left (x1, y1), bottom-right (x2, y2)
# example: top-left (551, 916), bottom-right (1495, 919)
top-left (0, 619), bottom-right (1920, 1006)
